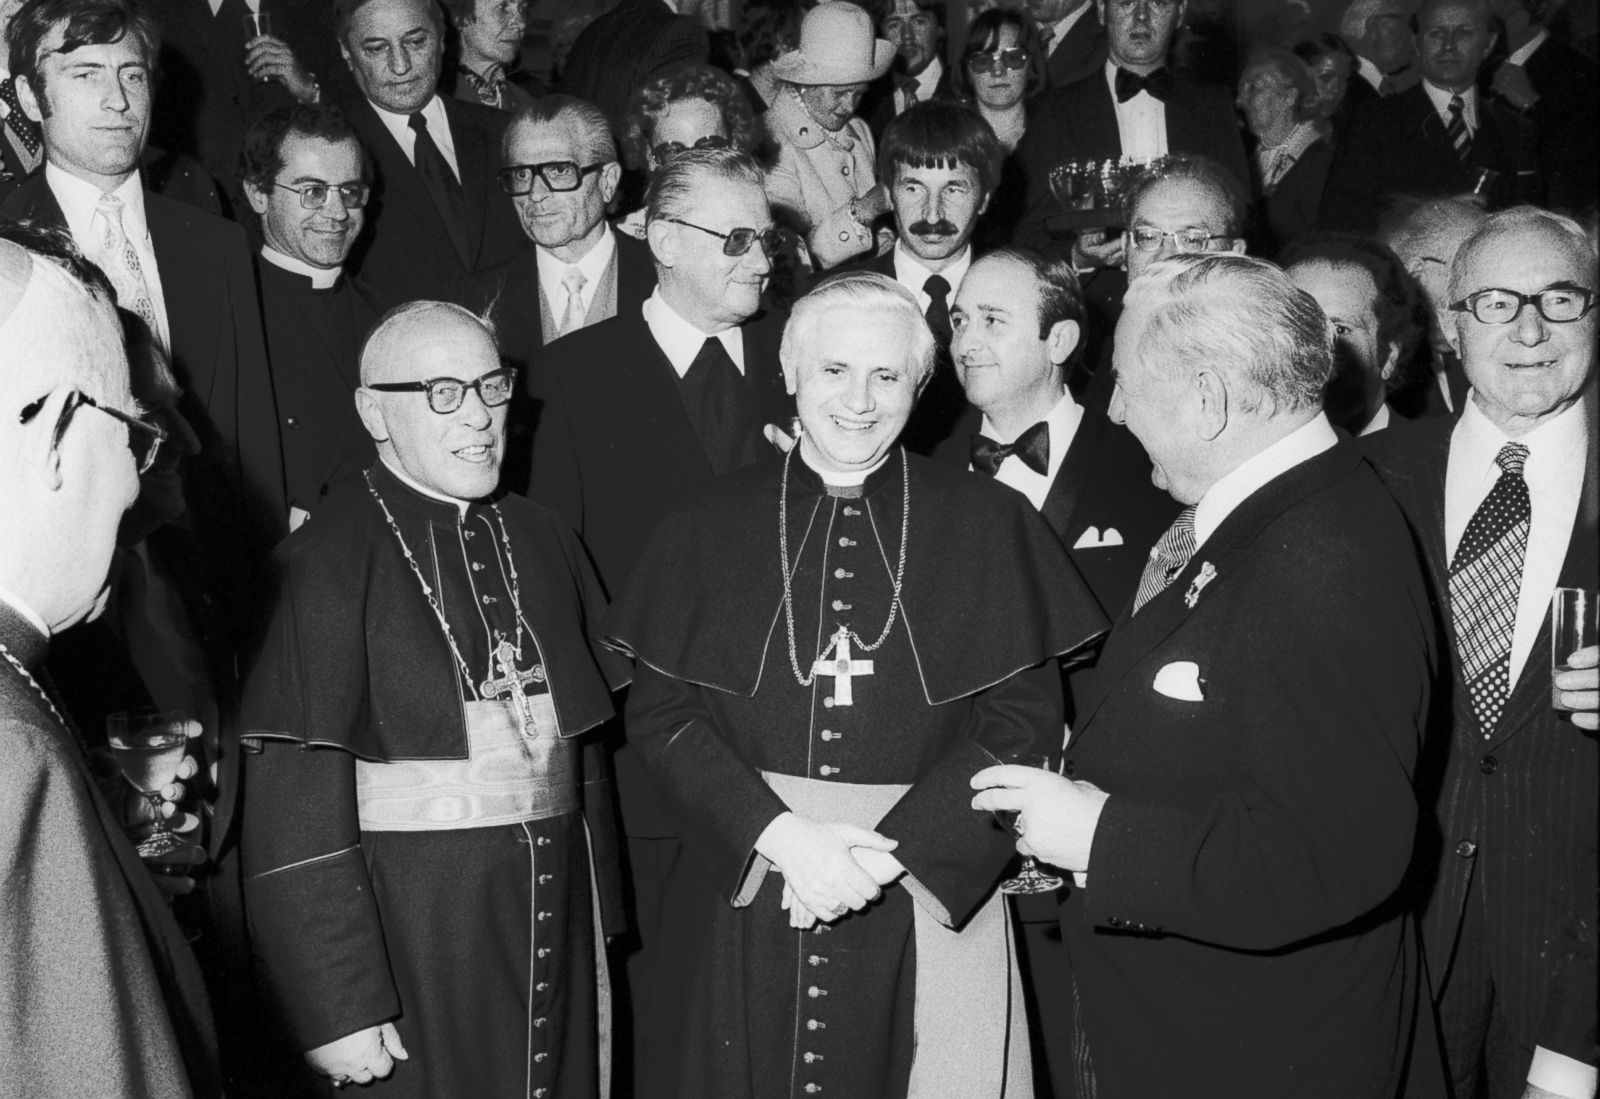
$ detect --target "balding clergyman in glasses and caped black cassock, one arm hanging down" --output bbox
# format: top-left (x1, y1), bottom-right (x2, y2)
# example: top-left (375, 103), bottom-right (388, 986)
top-left (240, 295), bottom-right (626, 1099)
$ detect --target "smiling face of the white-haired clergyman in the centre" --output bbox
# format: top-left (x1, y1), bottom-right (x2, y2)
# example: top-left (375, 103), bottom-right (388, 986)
top-left (784, 306), bottom-right (918, 474)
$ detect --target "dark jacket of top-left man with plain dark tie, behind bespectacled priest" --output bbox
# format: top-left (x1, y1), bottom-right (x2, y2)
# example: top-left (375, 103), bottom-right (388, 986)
top-left (347, 96), bottom-right (526, 304)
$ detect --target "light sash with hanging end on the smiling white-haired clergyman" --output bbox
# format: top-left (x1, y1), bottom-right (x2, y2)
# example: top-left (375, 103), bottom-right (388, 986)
top-left (733, 773), bottom-right (1034, 1099)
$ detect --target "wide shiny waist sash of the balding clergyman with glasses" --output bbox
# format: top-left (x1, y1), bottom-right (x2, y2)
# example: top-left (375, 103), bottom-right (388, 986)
top-left (355, 694), bottom-right (579, 832)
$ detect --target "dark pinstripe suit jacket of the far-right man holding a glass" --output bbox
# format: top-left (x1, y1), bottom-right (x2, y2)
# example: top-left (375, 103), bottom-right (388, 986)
top-left (1373, 418), bottom-right (1600, 1064)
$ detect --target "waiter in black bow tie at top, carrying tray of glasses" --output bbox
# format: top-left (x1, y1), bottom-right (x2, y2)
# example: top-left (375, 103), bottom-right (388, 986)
top-left (1016, 0), bottom-right (1250, 254)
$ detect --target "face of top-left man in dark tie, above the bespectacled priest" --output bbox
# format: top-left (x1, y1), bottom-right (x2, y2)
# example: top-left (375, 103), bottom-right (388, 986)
top-left (339, 0), bottom-right (445, 115)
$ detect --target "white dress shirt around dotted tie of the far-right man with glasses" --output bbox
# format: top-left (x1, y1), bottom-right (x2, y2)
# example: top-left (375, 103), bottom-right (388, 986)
top-left (1445, 394), bottom-right (1589, 683)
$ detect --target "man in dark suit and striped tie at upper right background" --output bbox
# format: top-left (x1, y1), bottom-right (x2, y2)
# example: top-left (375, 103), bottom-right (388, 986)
top-left (1322, 0), bottom-right (1542, 232)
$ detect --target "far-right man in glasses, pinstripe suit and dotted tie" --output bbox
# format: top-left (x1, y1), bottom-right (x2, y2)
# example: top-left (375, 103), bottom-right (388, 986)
top-left (1378, 206), bottom-right (1600, 1099)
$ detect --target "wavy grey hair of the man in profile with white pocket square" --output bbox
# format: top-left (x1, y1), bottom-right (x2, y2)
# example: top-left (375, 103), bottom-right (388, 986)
top-left (1123, 254), bottom-right (1333, 413)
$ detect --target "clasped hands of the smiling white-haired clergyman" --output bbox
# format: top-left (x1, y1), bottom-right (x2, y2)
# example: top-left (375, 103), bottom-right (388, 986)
top-left (755, 813), bottom-right (906, 929)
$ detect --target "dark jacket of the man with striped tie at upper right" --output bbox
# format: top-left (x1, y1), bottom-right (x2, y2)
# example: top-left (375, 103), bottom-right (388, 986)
top-left (1322, 85), bottom-right (1544, 232)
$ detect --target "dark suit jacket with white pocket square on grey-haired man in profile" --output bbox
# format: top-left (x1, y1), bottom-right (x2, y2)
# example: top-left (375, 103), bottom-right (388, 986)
top-left (1061, 442), bottom-right (1438, 1099)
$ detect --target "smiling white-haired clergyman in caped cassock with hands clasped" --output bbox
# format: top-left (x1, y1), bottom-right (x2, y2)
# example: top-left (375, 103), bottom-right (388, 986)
top-left (605, 272), bottom-right (1104, 1099)
